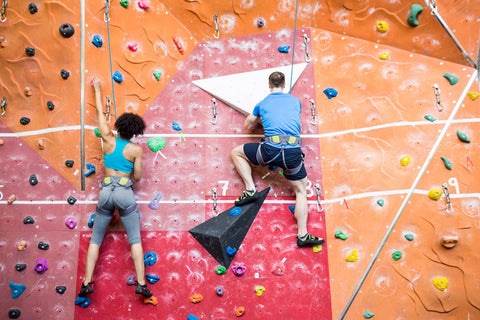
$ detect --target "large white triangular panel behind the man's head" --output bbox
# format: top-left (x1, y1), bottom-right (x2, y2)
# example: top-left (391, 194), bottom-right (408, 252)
top-left (192, 63), bottom-right (307, 115)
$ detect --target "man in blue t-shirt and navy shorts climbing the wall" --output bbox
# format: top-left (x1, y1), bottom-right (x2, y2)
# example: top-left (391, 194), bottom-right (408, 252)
top-left (232, 72), bottom-right (324, 247)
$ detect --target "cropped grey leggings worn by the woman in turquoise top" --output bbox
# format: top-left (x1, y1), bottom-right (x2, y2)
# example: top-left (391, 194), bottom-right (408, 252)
top-left (90, 176), bottom-right (141, 246)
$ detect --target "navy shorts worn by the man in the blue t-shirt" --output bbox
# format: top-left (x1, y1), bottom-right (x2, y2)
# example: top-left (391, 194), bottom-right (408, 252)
top-left (243, 143), bottom-right (307, 180)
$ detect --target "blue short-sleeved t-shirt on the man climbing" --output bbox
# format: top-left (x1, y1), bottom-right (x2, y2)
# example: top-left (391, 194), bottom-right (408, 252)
top-left (252, 92), bottom-right (302, 148)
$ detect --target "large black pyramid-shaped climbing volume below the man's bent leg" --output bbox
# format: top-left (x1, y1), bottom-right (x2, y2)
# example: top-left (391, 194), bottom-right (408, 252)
top-left (189, 188), bottom-right (270, 268)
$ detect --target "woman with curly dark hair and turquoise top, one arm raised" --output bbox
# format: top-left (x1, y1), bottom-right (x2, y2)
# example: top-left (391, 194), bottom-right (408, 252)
top-left (78, 77), bottom-right (152, 298)
